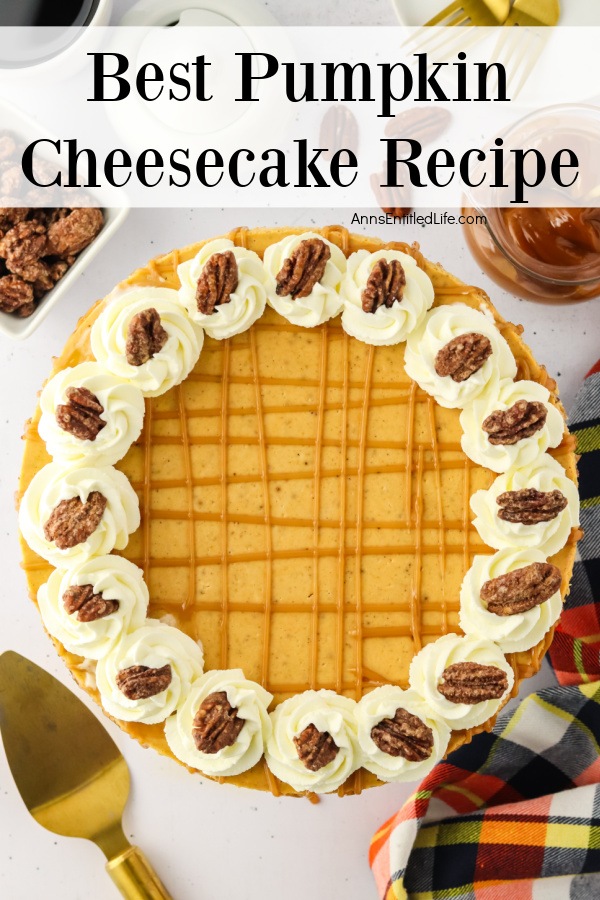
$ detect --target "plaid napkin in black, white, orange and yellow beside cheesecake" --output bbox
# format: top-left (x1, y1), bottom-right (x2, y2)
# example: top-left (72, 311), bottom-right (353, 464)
top-left (369, 362), bottom-right (600, 900)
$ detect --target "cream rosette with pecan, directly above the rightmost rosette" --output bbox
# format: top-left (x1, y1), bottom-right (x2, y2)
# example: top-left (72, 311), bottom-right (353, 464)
top-left (460, 379), bottom-right (565, 472)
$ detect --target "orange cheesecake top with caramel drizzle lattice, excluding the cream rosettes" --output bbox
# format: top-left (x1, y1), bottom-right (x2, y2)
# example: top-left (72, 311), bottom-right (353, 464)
top-left (22, 228), bottom-right (574, 793)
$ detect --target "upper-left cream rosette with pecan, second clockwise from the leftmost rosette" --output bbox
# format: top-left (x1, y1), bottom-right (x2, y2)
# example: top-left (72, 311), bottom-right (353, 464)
top-left (91, 286), bottom-right (204, 397)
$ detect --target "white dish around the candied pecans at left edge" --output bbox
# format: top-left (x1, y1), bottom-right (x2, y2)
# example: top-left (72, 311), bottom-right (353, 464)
top-left (0, 103), bottom-right (129, 341)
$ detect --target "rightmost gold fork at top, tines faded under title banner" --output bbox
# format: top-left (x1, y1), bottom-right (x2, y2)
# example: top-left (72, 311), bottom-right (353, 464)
top-left (491, 0), bottom-right (560, 99)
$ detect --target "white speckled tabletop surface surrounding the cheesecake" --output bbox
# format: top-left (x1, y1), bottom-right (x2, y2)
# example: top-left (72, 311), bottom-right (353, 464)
top-left (0, 210), bottom-right (600, 900)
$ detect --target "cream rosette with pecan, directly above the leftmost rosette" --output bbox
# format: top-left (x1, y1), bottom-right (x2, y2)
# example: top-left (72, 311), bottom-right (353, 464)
top-left (38, 362), bottom-right (144, 466)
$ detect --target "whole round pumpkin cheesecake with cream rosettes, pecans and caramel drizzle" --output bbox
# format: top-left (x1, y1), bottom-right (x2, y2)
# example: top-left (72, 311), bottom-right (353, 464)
top-left (20, 227), bottom-right (578, 796)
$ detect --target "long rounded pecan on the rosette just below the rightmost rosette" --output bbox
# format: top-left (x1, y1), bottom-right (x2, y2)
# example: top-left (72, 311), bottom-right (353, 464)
top-left (481, 563), bottom-right (562, 616)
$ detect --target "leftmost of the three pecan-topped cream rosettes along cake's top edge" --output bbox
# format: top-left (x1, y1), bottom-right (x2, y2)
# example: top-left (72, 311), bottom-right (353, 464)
top-left (177, 238), bottom-right (267, 341)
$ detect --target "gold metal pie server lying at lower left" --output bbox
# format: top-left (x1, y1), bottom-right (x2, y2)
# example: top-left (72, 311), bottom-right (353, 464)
top-left (0, 650), bottom-right (171, 900)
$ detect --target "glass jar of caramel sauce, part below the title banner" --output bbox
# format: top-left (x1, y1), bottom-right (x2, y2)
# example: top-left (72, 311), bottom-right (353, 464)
top-left (463, 206), bottom-right (600, 302)
